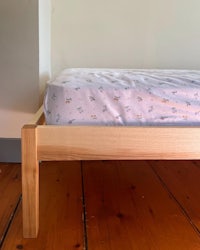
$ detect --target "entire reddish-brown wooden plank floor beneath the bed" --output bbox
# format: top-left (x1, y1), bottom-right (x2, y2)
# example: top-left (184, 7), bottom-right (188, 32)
top-left (0, 161), bottom-right (200, 250)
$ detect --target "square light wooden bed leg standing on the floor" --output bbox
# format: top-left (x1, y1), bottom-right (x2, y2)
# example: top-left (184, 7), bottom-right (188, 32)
top-left (22, 125), bottom-right (39, 238)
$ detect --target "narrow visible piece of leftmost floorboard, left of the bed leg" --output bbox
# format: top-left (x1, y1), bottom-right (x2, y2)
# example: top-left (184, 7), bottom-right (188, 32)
top-left (0, 163), bottom-right (21, 246)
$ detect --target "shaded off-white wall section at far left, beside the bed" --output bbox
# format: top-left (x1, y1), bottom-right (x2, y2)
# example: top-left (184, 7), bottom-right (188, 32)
top-left (0, 0), bottom-right (39, 138)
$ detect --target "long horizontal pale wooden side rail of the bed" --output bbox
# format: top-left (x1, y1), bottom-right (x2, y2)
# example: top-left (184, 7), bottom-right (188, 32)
top-left (37, 126), bottom-right (200, 161)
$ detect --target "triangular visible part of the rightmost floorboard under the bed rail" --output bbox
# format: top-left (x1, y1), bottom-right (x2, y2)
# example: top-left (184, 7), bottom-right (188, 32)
top-left (149, 161), bottom-right (200, 231)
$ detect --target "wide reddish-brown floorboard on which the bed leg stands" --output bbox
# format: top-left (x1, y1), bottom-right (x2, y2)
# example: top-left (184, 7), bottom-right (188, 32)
top-left (2, 162), bottom-right (84, 250)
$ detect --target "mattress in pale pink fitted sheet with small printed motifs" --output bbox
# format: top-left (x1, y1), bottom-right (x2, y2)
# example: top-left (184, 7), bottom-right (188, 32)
top-left (44, 69), bottom-right (200, 126)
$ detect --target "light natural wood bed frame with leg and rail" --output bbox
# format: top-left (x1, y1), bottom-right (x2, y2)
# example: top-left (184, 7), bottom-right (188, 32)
top-left (22, 107), bottom-right (200, 238)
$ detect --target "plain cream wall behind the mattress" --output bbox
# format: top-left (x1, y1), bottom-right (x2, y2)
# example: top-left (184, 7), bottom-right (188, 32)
top-left (52, 0), bottom-right (200, 75)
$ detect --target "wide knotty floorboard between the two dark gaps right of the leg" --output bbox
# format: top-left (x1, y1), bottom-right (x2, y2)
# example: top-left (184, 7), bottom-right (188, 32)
top-left (83, 161), bottom-right (200, 250)
